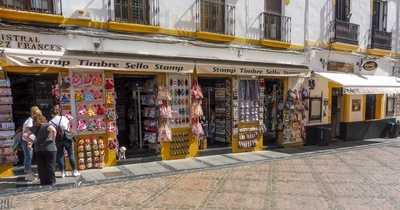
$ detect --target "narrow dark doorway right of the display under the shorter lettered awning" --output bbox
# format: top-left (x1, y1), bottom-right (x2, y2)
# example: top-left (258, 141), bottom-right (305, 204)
top-left (264, 79), bottom-right (284, 147)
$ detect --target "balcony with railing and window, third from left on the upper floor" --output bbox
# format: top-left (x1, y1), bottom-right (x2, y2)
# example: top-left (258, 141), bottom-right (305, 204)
top-left (196, 0), bottom-right (235, 35)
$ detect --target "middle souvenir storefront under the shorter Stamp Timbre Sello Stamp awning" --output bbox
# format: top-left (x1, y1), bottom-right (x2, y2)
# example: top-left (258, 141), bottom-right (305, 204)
top-left (196, 64), bottom-right (309, 152)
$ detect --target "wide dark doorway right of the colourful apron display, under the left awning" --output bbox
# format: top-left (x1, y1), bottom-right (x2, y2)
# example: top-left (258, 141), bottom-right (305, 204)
top-left (114, 75), bottom-right (160, 158)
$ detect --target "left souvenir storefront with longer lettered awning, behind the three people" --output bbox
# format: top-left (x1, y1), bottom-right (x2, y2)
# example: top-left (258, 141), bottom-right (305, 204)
top-left (1, 51), bottom-right (198, 177)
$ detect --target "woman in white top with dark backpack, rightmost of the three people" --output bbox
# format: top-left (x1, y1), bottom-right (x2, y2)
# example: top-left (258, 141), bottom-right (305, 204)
top-left (50, 105), bottom-right (80, 178)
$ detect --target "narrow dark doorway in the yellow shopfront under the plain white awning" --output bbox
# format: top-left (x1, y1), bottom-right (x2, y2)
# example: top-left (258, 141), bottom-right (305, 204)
top-left (331, 88), bottom-right (342, 138)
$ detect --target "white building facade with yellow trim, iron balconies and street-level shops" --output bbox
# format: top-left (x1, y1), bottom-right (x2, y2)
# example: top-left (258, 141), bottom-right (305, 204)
top-left (0, 0), bottom-right (400, 176)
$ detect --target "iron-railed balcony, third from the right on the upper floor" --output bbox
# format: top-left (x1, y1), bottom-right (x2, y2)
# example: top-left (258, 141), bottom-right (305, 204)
top-left (259, 12), bottom-right (292, 43)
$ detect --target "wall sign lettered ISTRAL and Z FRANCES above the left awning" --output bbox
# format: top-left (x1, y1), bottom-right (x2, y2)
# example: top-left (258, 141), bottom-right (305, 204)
top-left (0, 31), bottom-right (63, 51)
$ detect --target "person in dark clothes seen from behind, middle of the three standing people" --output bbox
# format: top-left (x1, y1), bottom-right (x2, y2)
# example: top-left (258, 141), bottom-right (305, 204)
top-left (30, 115), bottom-right (57, 185)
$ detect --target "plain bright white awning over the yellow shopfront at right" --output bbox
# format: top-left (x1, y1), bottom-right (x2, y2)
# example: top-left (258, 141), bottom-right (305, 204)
top-left (315, 72), bottom-right (400, 95)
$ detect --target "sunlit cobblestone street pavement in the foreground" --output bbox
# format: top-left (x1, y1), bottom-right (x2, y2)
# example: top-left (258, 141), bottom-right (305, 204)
top-left (0, 142), bottom-right (400, 210)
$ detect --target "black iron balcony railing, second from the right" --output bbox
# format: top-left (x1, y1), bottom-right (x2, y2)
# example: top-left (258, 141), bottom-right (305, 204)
top-left (331, 20), bottom-right (360, 45)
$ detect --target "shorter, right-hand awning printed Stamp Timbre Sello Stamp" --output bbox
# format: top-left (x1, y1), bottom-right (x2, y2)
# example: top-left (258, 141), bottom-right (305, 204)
top-left (196, 63), bottom-right (310, 77)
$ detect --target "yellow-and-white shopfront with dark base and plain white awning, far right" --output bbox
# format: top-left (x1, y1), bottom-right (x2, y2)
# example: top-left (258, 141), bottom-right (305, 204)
top-left (314, 72), bottom-right (400, 140)
